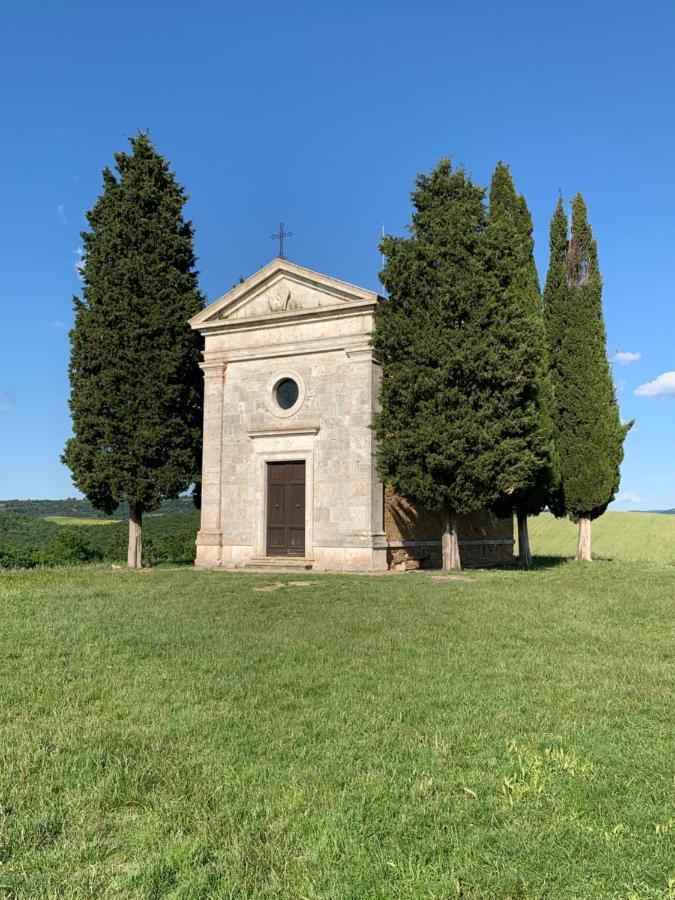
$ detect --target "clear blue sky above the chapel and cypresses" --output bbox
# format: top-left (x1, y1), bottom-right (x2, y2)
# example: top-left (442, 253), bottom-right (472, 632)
top-left (0, 0), bottom-right (675, 509)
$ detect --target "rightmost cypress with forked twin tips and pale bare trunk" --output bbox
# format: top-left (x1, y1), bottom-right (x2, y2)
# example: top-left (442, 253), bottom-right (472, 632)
top-left (544, 194), bottom-right (632, 561)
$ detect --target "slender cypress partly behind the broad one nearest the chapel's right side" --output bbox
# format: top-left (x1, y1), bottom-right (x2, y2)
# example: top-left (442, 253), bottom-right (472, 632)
top-left (485, 162), bottom-right (557, 568)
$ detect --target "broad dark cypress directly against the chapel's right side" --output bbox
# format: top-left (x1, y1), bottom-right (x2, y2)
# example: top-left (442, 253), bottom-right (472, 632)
top-left (372, 160), bottom-right (504, 569)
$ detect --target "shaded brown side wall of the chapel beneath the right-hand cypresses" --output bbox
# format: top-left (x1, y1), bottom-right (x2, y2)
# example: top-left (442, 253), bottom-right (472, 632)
top-left (384, 485), bottom-right (514, 569)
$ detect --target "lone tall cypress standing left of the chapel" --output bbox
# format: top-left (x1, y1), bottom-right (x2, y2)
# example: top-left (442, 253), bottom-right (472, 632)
top-left (62, 134), bottom-right (203, 568)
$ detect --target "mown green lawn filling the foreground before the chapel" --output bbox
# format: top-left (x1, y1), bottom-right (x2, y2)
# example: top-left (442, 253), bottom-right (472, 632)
top-left (0, 562), bottom-right (675, 900)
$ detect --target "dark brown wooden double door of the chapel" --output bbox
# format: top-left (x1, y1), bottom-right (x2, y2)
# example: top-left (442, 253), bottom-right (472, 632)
top-left (267, 462), bottom-right (305, 556)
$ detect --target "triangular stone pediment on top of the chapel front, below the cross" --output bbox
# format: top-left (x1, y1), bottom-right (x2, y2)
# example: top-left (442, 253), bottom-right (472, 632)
top-left (190, 259), bottom-right (379, 329)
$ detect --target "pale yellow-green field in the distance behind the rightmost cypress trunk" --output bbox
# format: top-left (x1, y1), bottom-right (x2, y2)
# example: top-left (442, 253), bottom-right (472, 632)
top-left (529, 512), bottom-right (675, 565)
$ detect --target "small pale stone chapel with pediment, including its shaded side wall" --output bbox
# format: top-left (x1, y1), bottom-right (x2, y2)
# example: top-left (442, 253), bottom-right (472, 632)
top-left (190, 258), bottom-right (514, 571)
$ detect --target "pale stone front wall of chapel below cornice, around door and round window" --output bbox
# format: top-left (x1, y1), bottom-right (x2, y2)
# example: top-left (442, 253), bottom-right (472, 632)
top-left (198, 340), bottom-right (386, 571)
